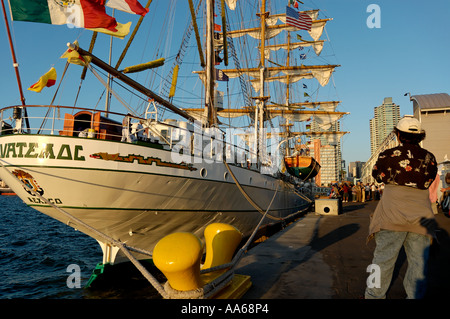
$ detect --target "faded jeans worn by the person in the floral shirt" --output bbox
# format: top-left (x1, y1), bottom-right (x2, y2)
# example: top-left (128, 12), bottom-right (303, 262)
top-left (365, 230), bottom-right (430, 299)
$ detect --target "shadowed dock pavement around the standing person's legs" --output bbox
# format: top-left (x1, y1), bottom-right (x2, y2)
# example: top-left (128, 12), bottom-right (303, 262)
top-left (236, 201), bottom-right (450, 299)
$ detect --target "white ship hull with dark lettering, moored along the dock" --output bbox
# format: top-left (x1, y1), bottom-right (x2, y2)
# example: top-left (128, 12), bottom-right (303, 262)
top-left (0, 134), bottom-right (310, 263)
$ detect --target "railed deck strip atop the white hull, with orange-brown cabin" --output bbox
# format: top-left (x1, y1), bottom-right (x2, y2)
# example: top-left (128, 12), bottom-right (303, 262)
top-left (0, 105), bottom-right (264, 170)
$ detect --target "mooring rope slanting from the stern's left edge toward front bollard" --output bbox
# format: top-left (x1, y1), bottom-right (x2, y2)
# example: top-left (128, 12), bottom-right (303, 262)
top-left (0, 159), bottom-right (169, 299)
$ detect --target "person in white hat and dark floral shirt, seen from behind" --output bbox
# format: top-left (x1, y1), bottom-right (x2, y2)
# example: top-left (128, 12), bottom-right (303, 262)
top-left (365, 117), bottom-right (437, 299)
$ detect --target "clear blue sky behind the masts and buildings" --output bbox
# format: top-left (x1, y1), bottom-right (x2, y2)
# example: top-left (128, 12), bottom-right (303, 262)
top-left (0, 0), bottom-right (450, 170)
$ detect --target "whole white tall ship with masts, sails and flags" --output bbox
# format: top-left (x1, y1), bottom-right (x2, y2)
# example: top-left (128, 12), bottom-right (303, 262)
top-left (0, 0), bottom-right (346, 270)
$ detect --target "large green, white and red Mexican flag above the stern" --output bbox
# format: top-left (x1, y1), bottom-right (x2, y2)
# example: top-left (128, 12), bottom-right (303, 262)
top-left (9, 0), bottom-right (147, 38)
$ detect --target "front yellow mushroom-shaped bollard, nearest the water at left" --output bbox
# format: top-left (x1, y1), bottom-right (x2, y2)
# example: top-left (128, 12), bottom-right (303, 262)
top-left (153, 233), bottom-right (203, 291)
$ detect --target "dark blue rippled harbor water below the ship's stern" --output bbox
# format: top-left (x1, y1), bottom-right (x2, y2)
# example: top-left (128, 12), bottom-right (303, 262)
top-left (0, 196), bottom-right (163, 299)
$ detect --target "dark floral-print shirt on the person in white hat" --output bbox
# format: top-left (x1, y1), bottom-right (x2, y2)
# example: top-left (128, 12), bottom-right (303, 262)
top-left (372, 143), bottom-right (437, 189)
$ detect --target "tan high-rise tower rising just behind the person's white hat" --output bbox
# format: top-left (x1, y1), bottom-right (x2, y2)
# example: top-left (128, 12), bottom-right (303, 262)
top-left (370, 97), bottom-right (400, 154)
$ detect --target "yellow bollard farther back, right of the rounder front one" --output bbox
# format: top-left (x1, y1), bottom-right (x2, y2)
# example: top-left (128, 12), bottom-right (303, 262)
top-left (202, 223), bottom-right (242, 269)
